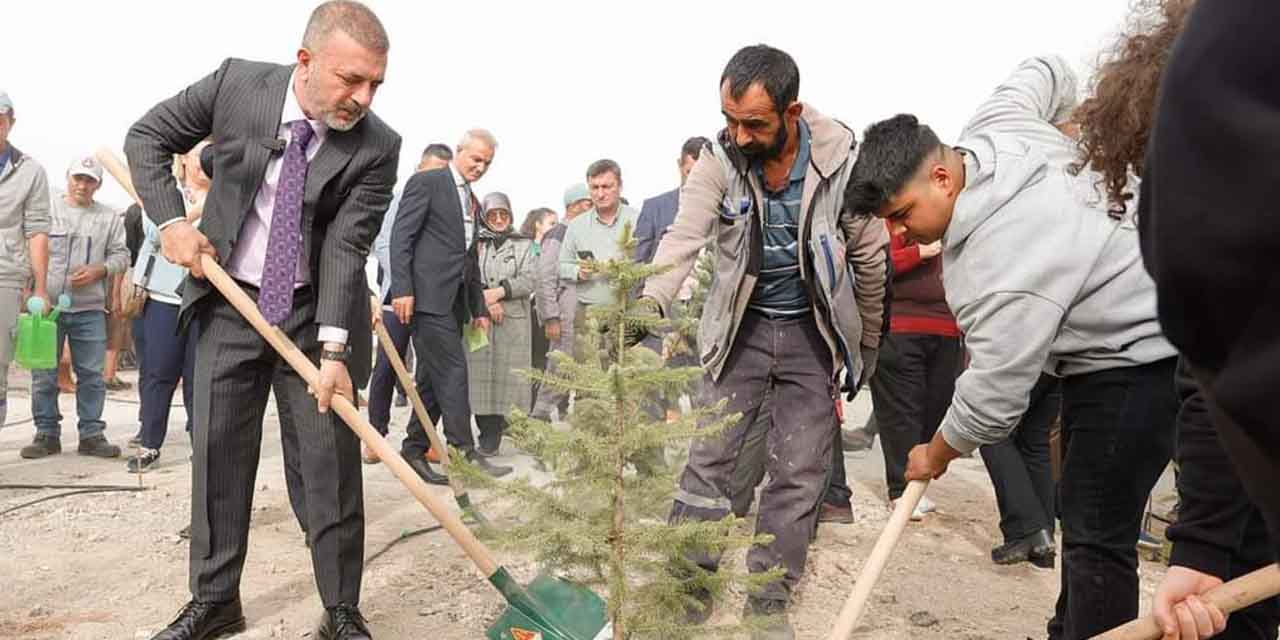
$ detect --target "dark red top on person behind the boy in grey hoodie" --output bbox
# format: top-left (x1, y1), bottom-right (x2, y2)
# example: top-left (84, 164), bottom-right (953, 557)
top-left (886, 223), bottom-right (960, 338)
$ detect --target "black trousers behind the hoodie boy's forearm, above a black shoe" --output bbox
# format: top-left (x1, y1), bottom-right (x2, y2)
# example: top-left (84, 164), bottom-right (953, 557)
top-left (982, 374), bottom-right (1062, 543)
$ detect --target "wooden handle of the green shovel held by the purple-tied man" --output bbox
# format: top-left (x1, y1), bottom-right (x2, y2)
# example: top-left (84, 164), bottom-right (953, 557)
top-left (200, 256), bottom-right (498, 577)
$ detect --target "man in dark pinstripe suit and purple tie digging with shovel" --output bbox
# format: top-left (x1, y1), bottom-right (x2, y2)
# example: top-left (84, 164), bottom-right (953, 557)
top-left (125, 0), bottom-right (401, 640)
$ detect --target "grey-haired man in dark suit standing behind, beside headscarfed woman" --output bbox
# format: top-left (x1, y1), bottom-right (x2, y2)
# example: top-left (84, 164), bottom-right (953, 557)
top-left (390, 129), bottom-right (511, 476)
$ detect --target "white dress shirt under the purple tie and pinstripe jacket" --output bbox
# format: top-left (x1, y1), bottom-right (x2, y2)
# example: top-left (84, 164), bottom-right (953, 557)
top-left (227, 68), bottom-right (347, 343)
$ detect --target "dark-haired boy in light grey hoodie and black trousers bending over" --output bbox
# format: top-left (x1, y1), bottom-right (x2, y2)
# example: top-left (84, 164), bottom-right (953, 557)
top-left (846, 58), bottom-right (1178, 640)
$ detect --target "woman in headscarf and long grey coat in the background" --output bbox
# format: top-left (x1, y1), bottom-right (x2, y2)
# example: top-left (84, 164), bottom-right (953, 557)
top-left (467, 192), bottom-right (536, 456)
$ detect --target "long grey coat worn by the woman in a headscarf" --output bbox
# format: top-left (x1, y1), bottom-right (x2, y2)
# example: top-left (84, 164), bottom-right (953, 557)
top-left (467, 237), bottom-right (538, 416)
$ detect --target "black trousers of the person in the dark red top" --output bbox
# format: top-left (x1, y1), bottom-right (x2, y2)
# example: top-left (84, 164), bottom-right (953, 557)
top-left (870, 333), bottom-right (964, 500)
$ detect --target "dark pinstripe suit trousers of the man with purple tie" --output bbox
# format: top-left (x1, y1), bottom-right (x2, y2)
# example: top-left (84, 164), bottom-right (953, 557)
top-left (191, 287), bottom-right (365, 607)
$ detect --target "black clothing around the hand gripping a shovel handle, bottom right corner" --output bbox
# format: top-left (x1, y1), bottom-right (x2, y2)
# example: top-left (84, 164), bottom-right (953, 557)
top-left (1167, 362), bottom-right (1280, 640)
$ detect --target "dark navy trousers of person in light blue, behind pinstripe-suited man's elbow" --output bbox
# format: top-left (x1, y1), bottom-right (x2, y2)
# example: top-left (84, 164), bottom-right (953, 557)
top-left (140, 300), bottom-right (196, 449)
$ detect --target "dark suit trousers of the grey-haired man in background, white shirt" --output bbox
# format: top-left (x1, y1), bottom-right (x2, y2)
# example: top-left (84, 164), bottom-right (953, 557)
top-left (401, 312), bottom-right (475, 456)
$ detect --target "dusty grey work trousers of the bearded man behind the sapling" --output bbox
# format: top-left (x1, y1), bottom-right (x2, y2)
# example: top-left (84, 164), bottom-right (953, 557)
top-left (671, 311), bottom-right (836, 600)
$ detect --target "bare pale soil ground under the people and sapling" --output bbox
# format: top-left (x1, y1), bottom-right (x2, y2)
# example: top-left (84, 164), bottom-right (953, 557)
top-left (0, 369), bottom-right (1164, 640)
